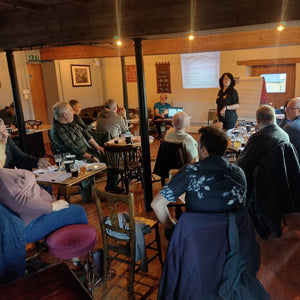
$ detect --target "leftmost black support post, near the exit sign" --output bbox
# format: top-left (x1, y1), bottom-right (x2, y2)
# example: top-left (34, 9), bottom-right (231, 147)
top-left (5, 50), bottom-right (27, 152)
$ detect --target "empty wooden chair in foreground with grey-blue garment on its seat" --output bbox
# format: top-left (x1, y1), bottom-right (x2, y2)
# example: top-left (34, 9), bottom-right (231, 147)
top-left (93, 186), bottom-right (162, 293)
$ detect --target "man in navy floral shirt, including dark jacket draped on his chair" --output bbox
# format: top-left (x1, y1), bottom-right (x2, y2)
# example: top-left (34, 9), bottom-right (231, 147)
top-left (151, 125), bottom-right (259, 299)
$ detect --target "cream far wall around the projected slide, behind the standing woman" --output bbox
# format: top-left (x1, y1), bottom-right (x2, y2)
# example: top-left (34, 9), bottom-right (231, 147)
top-left (105, 46), bottom-right (300, 122)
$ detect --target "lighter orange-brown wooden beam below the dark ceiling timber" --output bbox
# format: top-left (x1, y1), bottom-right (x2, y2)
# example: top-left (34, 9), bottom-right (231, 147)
top-left (40, 27), bottom-right (300, 60)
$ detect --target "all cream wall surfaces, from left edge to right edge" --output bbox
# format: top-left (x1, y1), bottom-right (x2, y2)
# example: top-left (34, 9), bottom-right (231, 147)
top-left (0, 46), bottom-right (300, 122)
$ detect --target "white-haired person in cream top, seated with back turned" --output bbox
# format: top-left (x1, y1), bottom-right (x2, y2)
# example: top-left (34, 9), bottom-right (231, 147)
top-left (165, 111), bottom-right (198, 163)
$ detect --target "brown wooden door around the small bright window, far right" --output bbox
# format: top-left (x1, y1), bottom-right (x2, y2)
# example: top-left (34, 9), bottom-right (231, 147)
top-left (252, 64), bottom-right (296, 109)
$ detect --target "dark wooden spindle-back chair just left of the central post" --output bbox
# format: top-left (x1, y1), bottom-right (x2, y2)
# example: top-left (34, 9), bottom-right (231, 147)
top-left (104, 143), bottom-right (143, 194)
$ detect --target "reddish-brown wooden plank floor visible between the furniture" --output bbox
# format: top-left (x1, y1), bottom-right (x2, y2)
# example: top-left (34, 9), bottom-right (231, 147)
top-left (40, 134), bottom-right (300, 300)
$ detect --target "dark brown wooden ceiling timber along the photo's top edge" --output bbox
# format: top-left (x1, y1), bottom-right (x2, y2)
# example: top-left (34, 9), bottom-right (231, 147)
top-left (0, 0), bottom-right (300, 49)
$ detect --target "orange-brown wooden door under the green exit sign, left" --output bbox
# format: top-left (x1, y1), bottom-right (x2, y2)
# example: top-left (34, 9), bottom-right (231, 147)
top-left (27, 64), bottom-right (49, 142)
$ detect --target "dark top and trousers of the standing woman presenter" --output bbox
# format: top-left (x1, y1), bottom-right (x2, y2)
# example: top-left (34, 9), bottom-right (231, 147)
top-left (216, 87), bottom-right (239, 130)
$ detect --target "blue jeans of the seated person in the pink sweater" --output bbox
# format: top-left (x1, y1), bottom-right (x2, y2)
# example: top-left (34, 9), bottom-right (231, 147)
top-left (25, 204), bottom-right (88, 244)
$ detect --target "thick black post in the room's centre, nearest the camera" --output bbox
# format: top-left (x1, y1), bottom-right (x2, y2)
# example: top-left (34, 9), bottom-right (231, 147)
top-left (134, 38), bottom-right (152, 211)
